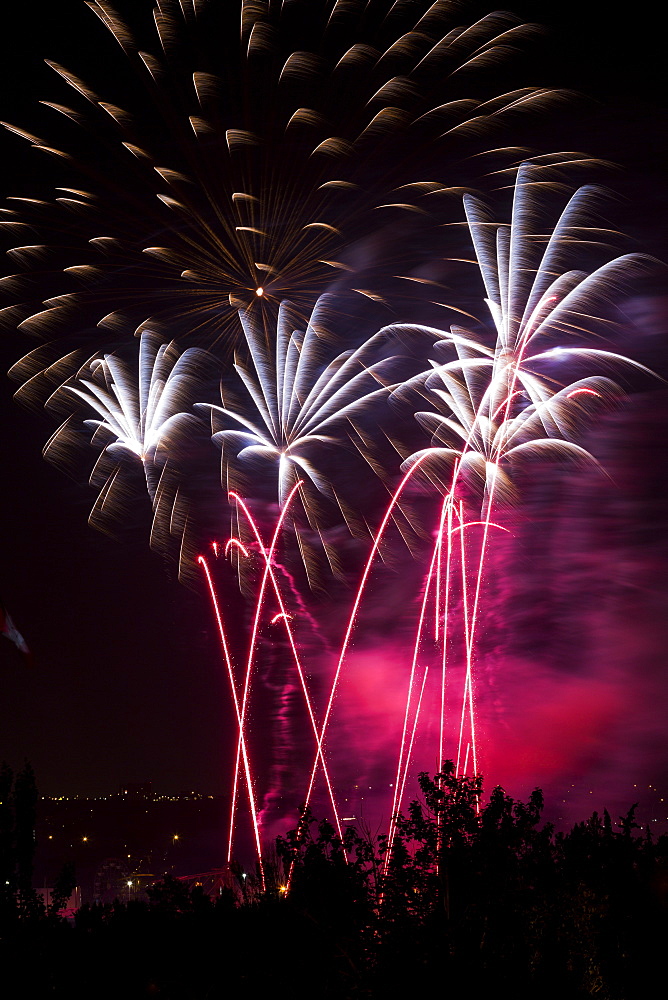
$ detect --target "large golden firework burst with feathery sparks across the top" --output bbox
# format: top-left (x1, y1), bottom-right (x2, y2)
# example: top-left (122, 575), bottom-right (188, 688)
top-left (4, 0), bottom-right (550, 376)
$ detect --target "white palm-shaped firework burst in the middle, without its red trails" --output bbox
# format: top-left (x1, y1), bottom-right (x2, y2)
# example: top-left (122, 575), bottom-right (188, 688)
top-left (198, 295), bottom-right (441, 583)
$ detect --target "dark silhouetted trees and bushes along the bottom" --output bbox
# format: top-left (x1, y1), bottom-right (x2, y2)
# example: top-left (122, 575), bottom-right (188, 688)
top-left (0, 763), bottom-right (668, 1000)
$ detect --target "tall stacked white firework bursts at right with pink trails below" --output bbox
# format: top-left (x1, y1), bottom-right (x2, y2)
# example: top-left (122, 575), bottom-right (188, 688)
top-left (384, 163), bottom-right (652, 824)
